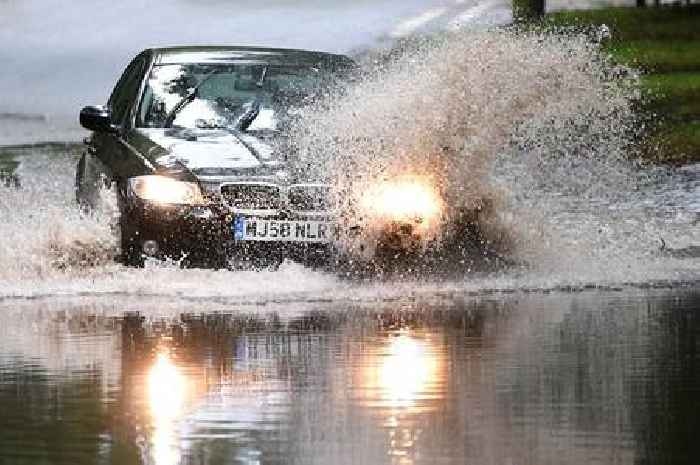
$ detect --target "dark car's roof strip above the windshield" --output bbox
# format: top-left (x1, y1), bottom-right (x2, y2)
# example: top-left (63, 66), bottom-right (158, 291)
top-left (145, 46), bottom-right (354, 67)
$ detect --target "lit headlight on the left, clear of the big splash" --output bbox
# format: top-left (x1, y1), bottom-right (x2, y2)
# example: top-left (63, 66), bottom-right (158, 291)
top-left (129, 175), bottom-right (204, 205)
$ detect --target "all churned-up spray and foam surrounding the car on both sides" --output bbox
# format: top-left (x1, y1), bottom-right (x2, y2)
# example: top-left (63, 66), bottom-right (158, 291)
top-left (0, 31), bottom-right (700, 302)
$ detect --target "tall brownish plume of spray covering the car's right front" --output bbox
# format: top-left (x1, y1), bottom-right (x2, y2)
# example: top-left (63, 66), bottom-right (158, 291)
top-left (297, 31), bottom-right (698, 280)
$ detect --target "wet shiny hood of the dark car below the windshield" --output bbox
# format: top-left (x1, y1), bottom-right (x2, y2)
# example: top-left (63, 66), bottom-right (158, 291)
top-left (139, 128), bottom-right (285, 177)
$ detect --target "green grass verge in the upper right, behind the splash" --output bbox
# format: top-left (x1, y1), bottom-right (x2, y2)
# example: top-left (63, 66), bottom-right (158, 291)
top-left (545, 5), bottom-right (700, 163)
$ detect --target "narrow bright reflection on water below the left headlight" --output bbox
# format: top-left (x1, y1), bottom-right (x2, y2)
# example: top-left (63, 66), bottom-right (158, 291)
top-left (148, 352), bottom-right (187, 465)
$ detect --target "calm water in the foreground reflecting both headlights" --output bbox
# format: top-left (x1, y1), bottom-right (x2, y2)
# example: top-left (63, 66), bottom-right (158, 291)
top-left (0, 289), bottom-right (700, 465)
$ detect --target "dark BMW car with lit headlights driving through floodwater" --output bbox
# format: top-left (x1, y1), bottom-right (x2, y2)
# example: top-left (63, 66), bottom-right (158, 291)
top-left (76, 46), bottom-right (492, 268)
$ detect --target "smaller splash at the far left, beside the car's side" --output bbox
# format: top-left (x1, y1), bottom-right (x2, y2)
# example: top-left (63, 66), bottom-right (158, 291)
top-left (0, 151), bottom-right (117, 281)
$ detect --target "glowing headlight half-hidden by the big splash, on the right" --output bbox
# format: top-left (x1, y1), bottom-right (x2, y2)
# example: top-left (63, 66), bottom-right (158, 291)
top-left (361, 178), bottom-right (443, 221)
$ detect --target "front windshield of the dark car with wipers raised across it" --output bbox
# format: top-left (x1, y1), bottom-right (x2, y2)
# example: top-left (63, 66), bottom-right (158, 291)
top-left (137, 64), bottom-right (340, 131)
